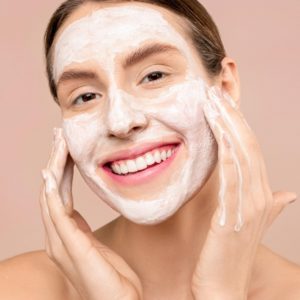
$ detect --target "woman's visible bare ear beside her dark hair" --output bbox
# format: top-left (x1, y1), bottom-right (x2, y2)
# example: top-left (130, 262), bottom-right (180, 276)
top-left (219, 57), bottom-right (240, 107)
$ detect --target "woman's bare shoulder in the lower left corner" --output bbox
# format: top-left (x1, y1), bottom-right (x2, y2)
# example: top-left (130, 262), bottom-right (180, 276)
top-left (0, 250), bottom-right (76, 300)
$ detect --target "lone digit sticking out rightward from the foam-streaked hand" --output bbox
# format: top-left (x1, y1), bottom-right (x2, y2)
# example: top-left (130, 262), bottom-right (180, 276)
top-left (267, 192), bottom-right (297, 227)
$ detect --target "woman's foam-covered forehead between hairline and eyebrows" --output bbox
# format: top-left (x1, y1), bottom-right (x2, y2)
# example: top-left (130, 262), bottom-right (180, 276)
top-left (53, 2), bottom-right (196, 79)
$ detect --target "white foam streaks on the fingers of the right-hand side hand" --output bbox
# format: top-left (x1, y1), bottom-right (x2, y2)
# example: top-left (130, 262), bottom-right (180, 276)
top-left (205, 87), bottom-right (247, 232)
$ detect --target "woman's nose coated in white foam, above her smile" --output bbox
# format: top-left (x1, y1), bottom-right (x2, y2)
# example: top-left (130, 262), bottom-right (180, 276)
top-left (106, 90), bottom-right (148, 139)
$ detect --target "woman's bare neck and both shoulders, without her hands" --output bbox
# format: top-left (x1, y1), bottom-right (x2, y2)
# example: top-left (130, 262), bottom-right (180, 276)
top-left (0, 152), bottom-right (300, 300)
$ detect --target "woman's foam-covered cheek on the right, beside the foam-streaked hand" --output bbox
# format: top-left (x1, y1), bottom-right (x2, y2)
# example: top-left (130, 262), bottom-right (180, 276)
top-left (151, 80), bottom-right (217, 171)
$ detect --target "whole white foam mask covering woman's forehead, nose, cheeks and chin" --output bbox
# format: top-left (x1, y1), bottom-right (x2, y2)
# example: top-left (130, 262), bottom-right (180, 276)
top-left (54, 4), bottom-right (217, 224)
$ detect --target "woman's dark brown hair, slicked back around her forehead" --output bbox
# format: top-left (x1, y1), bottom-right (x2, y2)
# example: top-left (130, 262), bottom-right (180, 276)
top-left (44, 0), bottom-right (226, 99)
